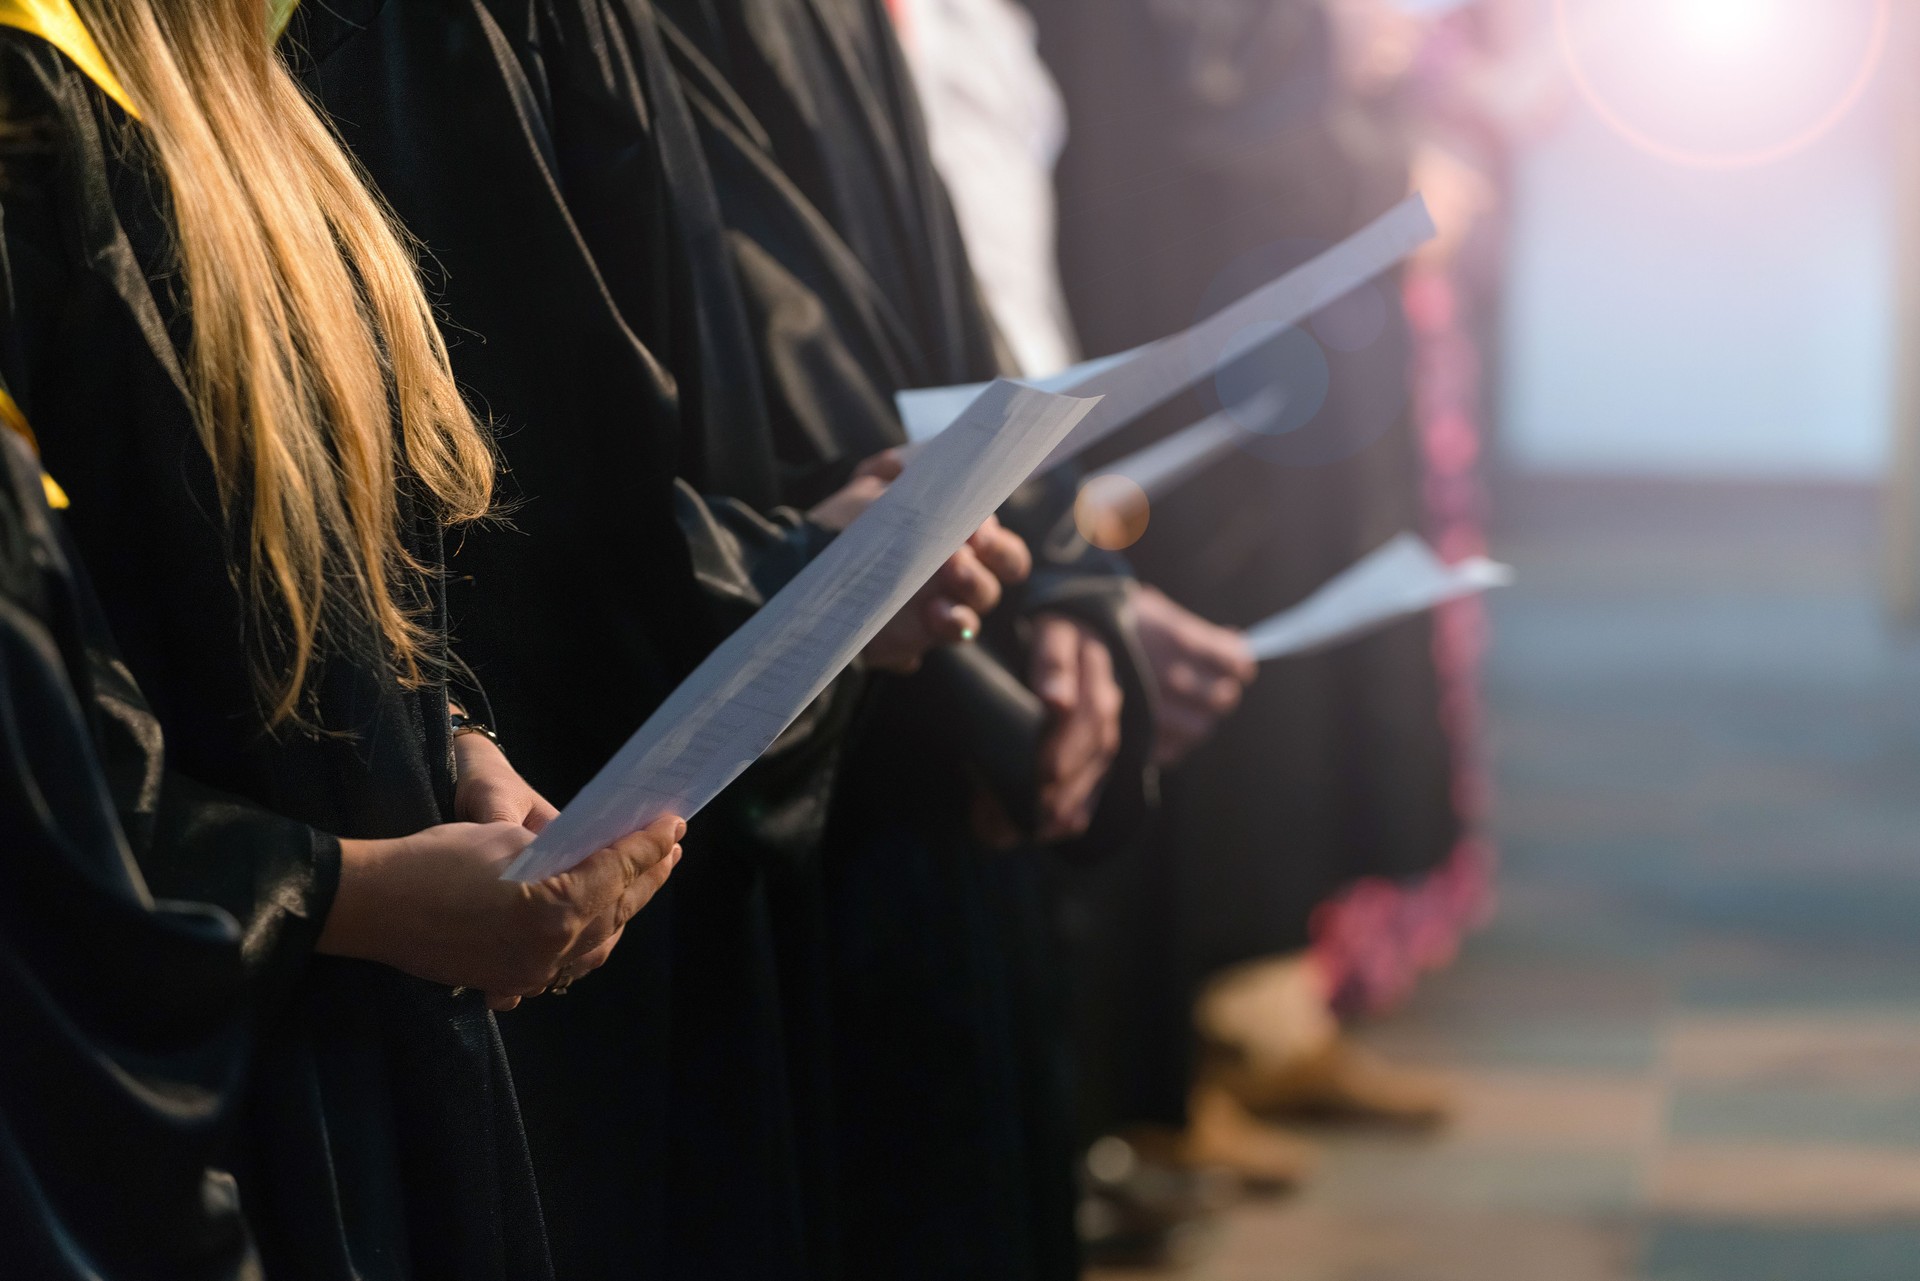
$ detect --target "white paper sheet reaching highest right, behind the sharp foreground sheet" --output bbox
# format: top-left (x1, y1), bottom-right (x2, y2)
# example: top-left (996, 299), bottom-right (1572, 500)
top-left (895, 194), bottom-right (1436, 471)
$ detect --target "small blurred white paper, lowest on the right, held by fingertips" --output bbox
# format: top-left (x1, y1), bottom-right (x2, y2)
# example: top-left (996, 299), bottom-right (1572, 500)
top-left (1246, 534), bottom-right (1513, 663)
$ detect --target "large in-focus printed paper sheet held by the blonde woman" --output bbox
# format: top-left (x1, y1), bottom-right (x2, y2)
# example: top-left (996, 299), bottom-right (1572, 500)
top-left (507, 382), bottom-right (1096, 882)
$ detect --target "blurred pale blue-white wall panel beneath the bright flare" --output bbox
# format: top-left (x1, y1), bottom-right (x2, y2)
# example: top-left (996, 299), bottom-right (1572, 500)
top-left (1501, 0), bottom-right (1907, 482)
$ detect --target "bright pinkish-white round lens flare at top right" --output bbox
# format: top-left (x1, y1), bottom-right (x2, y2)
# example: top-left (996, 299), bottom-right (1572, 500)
top-left (1553, 0), bottom-right (1893, 169)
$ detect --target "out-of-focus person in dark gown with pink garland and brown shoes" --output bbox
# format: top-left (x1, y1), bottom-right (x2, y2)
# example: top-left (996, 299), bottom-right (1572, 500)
top-left (1033, 0), bottom-right (1512, 1259)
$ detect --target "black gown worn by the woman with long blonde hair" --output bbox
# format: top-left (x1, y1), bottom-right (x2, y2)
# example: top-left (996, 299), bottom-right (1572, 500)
top-left (0, 33), bottom-right (549, 1281)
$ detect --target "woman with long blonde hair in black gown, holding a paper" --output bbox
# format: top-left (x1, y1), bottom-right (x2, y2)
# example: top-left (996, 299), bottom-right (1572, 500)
top-left (0, 0), bottom-right (674, 1281)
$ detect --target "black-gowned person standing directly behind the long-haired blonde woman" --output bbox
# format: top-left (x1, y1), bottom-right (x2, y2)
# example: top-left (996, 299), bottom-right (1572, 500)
top-left (288, 0), bottom-right (1018, 1277)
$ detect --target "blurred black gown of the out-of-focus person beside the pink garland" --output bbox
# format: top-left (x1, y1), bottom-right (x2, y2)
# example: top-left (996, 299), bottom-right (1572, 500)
top-left (1031, 0), bottom-right (1459, 1122)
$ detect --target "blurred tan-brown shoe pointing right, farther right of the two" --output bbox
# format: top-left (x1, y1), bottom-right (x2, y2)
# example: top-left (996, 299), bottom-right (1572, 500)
top-left (1204, 1037), bottom-right (1453, 1129)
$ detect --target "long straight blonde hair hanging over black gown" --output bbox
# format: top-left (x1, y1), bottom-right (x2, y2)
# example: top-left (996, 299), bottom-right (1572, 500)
top-left (73, 0), bottom-right (495, 724)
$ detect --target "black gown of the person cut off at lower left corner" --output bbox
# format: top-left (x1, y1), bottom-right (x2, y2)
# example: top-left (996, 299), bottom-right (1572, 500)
top-left (0, 430), bottom-right (259, 1281)
